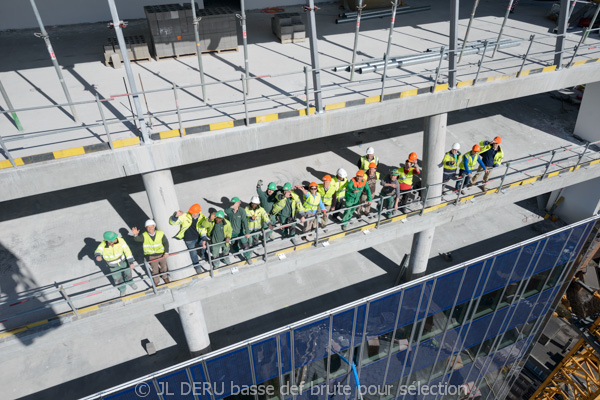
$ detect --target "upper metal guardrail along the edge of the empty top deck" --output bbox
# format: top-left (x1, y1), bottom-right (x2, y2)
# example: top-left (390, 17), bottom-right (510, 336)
top-left (0, 25), bottom-right (600, 167)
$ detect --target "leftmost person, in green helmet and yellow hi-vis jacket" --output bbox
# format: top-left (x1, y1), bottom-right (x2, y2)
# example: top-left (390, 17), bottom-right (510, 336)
top-left (94, 231), bottom-right (137, 296)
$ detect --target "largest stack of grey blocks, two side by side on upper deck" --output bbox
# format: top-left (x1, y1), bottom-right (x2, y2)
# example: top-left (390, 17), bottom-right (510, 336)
top-left (144, 3), bottom-right (237, 59)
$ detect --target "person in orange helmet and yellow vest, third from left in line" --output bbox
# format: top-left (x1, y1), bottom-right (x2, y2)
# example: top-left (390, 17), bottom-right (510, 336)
top-left (169, 204), bottom-right (208, 273)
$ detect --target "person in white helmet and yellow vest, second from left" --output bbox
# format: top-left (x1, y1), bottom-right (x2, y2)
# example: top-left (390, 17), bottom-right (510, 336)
top-left (131, 219), bottom-right (170, 285)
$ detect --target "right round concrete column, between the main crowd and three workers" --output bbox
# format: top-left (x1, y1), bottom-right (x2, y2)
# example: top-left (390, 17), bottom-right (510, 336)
top-left (407, 114), bottom-right (448, 280)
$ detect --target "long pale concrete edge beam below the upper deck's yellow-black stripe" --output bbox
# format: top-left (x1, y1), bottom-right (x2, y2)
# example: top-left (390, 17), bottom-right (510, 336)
top-left (0, 64), bottom-right (600, 202)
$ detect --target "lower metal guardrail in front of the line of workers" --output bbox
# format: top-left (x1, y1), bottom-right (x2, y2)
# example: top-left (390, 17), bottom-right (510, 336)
top-left (0, 141), bottom-right (600, 330)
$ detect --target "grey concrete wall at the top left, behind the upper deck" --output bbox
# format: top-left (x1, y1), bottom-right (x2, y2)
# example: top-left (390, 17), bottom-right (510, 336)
top-left (0, 0), bottom-right (304, 30)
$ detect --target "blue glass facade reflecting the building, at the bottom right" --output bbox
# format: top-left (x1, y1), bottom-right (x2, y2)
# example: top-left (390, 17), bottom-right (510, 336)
top-left (86, 219), bottom-right (596, 400)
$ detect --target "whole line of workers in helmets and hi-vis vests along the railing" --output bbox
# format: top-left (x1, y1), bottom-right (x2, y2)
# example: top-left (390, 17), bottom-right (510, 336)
top-left (95, 141), bottom-right (504, 295)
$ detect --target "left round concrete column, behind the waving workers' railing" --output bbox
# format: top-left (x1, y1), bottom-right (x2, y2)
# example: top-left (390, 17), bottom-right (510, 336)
top-left (142, 170), bottom-right (210, 356)
